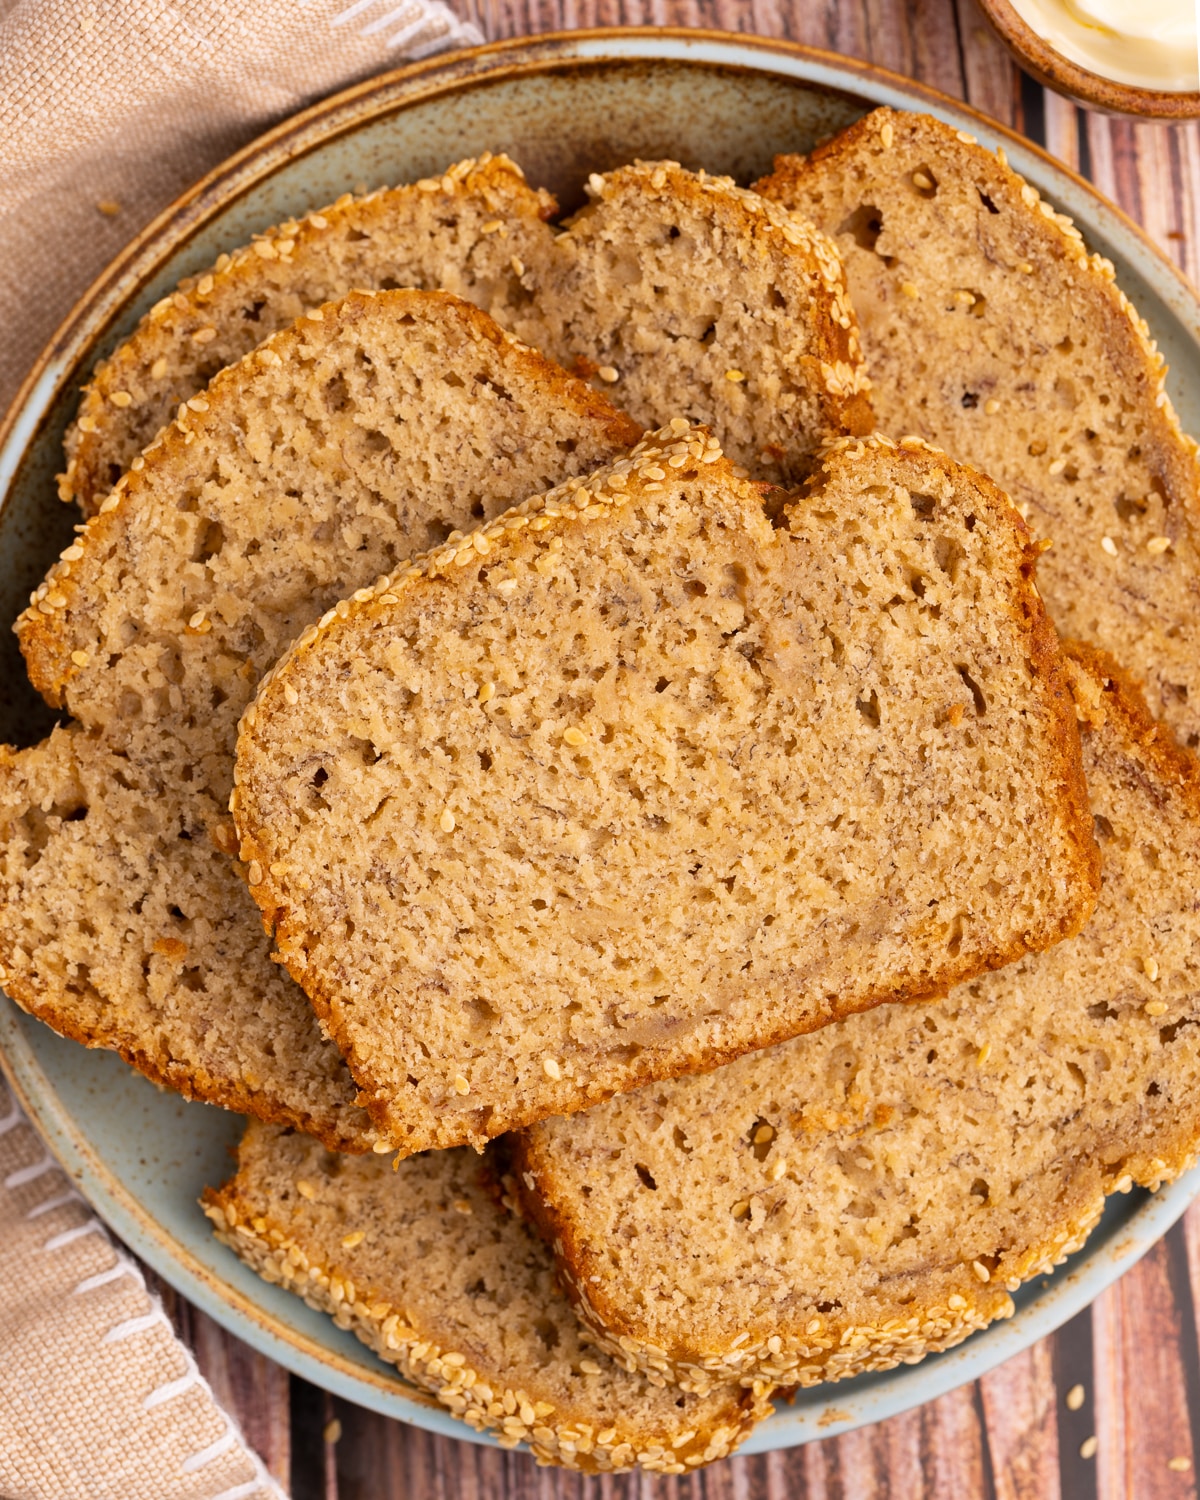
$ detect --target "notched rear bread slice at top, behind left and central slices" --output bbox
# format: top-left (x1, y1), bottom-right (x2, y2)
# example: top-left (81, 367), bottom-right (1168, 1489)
top-left (60, 155), bottom-right (873, 515)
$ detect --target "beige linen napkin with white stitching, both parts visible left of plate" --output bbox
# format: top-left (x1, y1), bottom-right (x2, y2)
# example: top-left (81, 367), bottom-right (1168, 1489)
top-left (0, 0), bottom-right (482, 1500)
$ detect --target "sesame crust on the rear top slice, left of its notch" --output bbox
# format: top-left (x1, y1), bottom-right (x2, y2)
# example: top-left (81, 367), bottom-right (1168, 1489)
top-left (59, 153), bottom-right (558, 516)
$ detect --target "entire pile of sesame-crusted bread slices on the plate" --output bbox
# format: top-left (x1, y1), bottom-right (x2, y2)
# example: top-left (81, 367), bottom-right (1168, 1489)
top-left (0, 120), bottom-right (1200, 1473)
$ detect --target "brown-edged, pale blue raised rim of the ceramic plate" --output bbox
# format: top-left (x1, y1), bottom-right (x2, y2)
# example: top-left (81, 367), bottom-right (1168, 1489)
top-left (0, 27), bottom-right (1200, 1454)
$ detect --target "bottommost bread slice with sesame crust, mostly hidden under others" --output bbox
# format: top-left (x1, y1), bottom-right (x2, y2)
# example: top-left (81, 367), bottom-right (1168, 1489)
top-left (204, 1124), bottom-right (770, 1475)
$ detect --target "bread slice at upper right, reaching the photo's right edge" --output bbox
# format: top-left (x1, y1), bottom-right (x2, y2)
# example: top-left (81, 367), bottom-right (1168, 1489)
top-left (758, 110), bottom-right (1200, 747)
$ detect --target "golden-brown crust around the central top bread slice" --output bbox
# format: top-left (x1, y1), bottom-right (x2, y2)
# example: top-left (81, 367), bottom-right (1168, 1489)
top-left (230, 422), bottom-right (1100, 1154)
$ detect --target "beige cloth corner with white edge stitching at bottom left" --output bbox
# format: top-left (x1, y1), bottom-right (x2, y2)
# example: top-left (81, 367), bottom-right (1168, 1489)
top-left (0, 1082), bottom-right (284, 1500)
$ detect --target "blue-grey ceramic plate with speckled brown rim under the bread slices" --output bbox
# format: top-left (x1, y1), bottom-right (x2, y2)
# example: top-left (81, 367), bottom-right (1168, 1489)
top-left (0, 30), bottom-right (1200, 1452)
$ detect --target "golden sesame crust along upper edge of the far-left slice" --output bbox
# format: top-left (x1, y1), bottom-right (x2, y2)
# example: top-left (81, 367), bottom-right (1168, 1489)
top-left (21, 291), bottom-right (641, 708)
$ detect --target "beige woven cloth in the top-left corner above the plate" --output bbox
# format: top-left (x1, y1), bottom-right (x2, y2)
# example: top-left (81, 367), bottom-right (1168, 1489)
top-left (0, 0), bottom-right (483, 413)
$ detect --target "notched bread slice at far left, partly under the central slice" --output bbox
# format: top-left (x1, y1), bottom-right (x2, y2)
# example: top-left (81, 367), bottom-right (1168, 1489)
top-left (0, 291), bottom-right (638, 1149)
